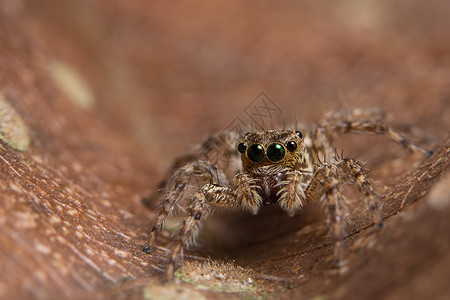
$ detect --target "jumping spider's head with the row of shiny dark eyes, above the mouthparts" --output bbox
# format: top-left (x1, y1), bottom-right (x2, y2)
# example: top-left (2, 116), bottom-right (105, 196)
top-left (237, 130), bottom-right (305, 170)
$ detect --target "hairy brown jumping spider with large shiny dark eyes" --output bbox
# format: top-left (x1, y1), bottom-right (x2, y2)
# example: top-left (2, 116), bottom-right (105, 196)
top-left (143, 109), bottom-right (432, 282)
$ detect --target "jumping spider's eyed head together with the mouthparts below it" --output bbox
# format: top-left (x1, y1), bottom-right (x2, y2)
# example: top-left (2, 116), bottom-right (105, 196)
top-left (235, 130), bottom-right (313, 214)
